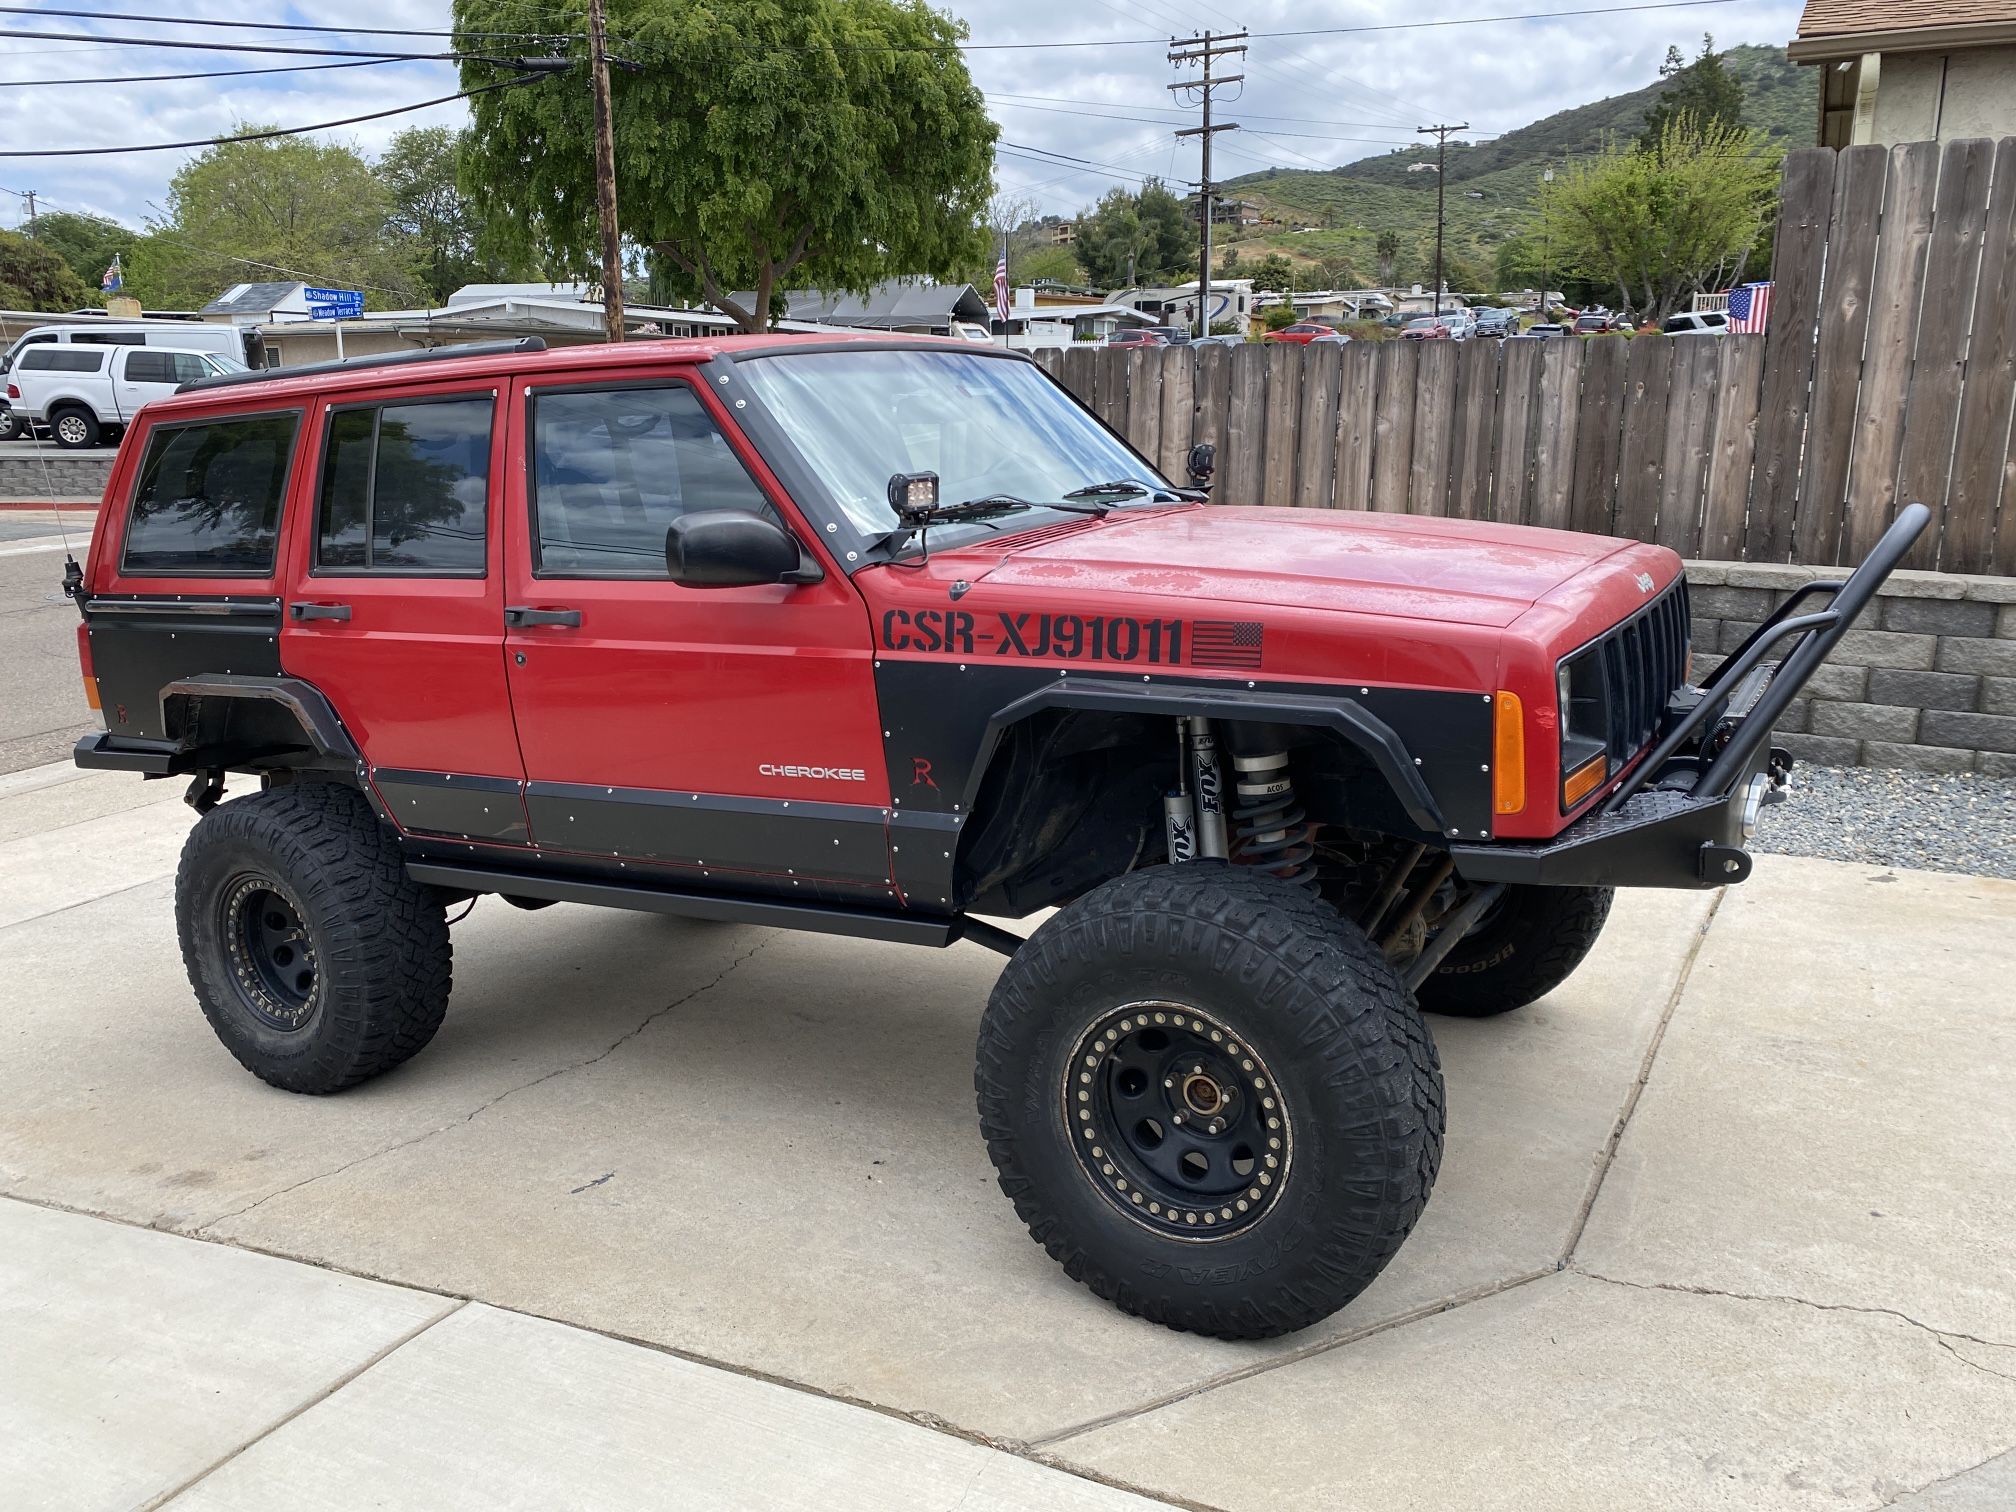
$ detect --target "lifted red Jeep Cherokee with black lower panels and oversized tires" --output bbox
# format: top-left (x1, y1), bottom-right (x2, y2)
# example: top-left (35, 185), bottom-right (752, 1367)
top-left (58, 337), bottom-right (1927, 1339)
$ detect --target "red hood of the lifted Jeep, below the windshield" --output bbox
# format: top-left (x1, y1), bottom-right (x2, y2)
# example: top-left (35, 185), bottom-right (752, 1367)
top-left (931, 506), bottom-right (1631, 629)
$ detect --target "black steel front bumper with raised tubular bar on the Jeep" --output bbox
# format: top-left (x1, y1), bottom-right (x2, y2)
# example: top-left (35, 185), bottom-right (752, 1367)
top-left (1450, 504), bottom-right (1931, 887)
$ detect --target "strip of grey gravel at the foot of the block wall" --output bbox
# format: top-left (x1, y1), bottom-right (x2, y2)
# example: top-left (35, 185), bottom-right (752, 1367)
top-left (1752, 762), bottom-right (2016, 881)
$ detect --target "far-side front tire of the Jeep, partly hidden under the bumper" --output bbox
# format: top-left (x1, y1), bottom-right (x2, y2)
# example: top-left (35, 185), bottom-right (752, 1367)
top-left (1415, 887), bottom-right (1613, 1018)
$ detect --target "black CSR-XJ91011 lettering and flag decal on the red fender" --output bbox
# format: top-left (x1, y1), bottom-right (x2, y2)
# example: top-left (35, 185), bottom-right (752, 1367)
top-left (881, 609), bottom-right (1266, 671)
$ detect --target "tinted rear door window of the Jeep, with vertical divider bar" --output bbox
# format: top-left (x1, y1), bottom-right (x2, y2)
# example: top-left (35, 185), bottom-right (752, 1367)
top-left (314, 397), bottom-right (496, 575)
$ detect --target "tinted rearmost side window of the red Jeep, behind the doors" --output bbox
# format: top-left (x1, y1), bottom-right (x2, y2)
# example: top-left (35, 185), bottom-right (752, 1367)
top-left (123, 415), bottom-right (300, 577)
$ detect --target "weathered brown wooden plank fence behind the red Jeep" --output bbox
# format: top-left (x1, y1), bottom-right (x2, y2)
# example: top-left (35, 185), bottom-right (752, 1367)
top-left (1038, 139), bottom-right (2016, 573)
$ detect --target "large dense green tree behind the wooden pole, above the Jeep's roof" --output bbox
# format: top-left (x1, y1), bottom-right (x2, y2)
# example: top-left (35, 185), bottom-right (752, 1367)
top-left (454, 0), bottom-right (996, 331)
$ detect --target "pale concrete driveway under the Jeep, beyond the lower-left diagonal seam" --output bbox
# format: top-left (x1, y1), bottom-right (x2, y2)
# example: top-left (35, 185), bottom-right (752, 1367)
top-left (0, 768), bottom-right (2016, 1510)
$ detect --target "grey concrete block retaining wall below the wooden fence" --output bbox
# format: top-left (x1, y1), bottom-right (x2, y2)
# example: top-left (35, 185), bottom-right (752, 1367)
top-left (1687, 562), bottom-right (2016, 776)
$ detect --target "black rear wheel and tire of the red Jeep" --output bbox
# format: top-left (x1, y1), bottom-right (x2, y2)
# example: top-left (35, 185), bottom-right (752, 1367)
top-left (175, 782), bottom-right (450, 1093)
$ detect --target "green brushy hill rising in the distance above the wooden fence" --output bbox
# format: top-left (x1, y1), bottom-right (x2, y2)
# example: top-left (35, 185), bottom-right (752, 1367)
top-left (1220, 46), bottom-right (1818, 284)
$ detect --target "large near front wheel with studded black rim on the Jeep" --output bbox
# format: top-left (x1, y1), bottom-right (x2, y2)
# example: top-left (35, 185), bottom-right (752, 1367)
top-left (974, 861), bottom-right (1443, 1339)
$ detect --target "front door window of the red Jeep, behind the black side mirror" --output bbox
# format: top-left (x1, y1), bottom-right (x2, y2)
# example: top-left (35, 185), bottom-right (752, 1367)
top-left (532, 385), bottom-right (774, 577)
